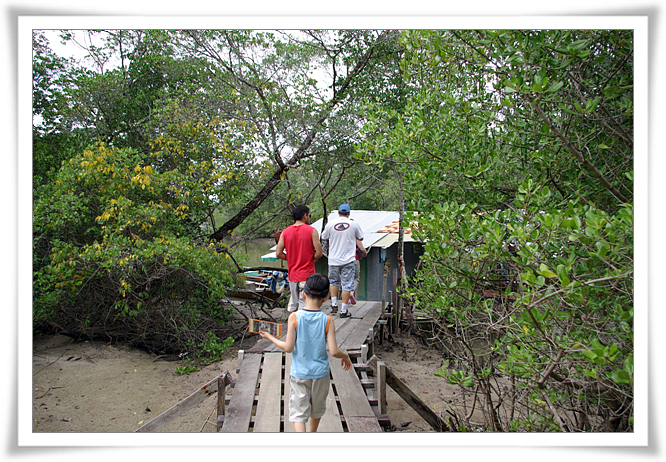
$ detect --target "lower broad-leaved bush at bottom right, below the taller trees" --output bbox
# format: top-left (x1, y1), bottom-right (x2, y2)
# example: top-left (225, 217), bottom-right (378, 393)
top-left (409, 184), bottom-right (634, 431)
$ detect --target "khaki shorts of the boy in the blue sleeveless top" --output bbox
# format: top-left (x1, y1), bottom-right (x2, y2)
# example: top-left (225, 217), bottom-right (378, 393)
top-left (289, 374), bottom-right (331, 423)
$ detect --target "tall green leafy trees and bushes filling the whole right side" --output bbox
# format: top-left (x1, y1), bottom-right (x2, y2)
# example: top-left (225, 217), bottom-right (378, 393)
top-left (357, 30), bottom-right (633, 431)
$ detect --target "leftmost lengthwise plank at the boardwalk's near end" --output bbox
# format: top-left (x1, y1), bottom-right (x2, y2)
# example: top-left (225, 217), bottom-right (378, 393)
top-left (221, 353), bottom-right (262, 432)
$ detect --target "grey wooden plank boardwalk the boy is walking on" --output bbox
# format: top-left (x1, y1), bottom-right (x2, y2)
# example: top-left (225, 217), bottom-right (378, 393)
top-left (218, 302), bottom-right (390, 432)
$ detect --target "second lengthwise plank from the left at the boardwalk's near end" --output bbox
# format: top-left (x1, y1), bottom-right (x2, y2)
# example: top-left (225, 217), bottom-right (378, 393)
top-left (253, 353), bottom-right (283, 433)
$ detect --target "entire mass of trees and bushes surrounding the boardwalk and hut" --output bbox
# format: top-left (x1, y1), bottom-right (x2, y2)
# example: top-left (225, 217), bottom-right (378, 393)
top-left (33, 29), bottom-right (634, 431)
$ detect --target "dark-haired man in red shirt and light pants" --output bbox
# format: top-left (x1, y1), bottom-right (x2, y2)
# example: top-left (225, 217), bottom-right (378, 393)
top-left (275, 205), bottom-right (322, 313)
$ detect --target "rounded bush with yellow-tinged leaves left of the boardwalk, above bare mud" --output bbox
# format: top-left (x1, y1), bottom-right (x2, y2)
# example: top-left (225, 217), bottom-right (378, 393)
top-left (33, 145), bottom-right (244, 350)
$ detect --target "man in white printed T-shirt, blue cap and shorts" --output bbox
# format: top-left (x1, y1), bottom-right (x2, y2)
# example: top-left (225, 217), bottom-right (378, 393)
top-left (321, 204), bottom-right (368, 318)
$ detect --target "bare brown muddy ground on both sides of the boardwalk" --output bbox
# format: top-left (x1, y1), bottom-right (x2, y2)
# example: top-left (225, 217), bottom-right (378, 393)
top-left (32, 310), bottom-right (472, 433)
